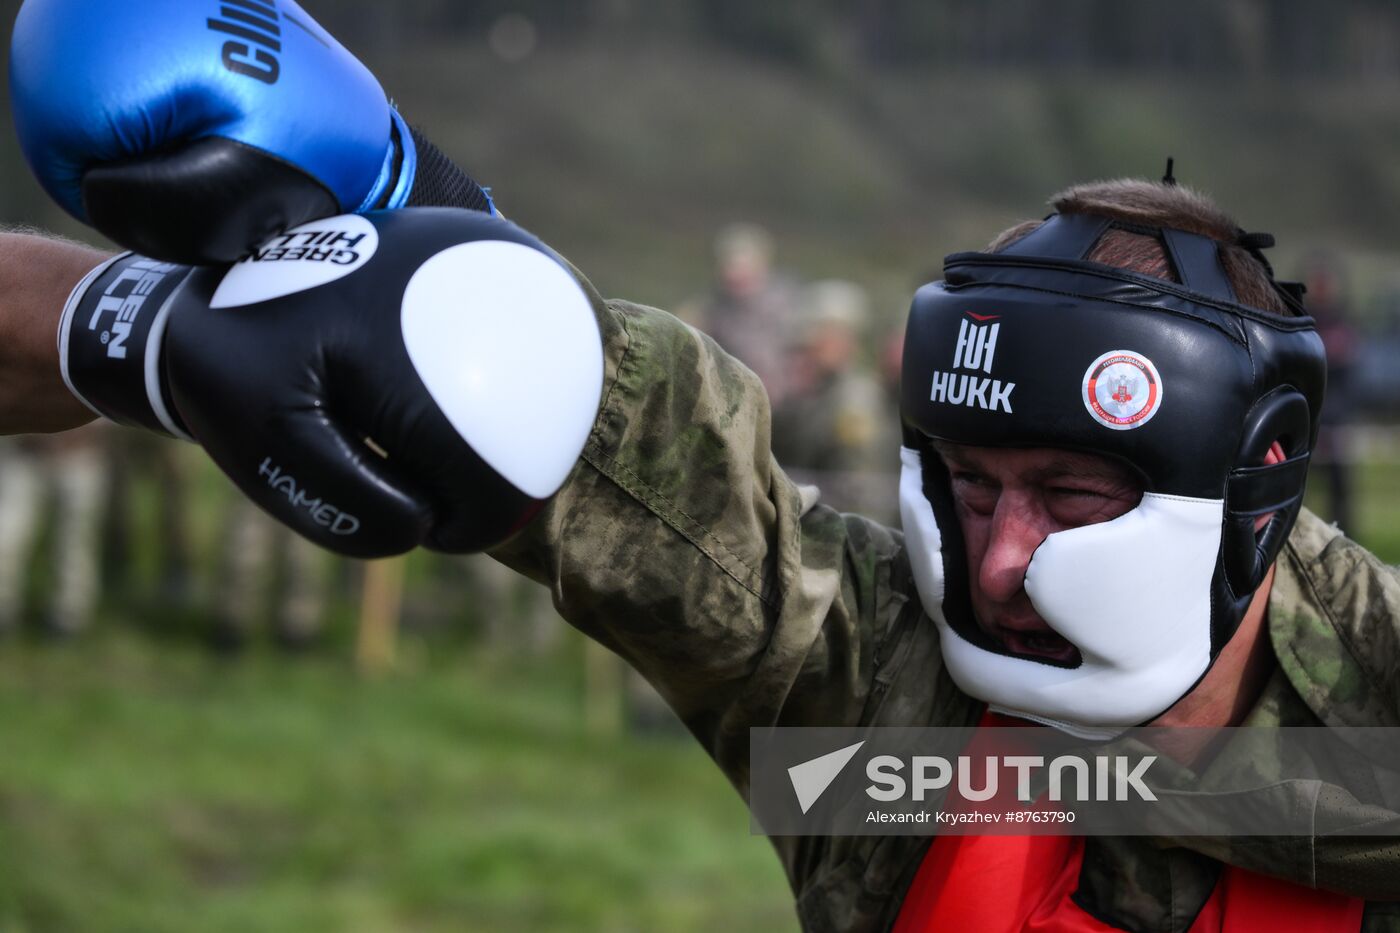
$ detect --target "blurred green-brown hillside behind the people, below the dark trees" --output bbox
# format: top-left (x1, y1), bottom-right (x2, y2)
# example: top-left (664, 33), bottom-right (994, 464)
top-left (0, 7), bottom-right (1400, 326)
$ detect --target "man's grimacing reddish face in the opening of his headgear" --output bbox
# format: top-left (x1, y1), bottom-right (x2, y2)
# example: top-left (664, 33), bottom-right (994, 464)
top-left (935, 441), bottom-right (1142, 664)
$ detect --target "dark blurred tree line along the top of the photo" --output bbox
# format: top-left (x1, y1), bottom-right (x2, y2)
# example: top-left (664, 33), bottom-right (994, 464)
top-left (318, 0), bottom-right (1400, 80)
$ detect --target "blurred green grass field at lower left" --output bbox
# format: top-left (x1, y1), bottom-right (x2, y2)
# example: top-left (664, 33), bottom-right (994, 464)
top-left (0, 619), bottom-right (795, 933)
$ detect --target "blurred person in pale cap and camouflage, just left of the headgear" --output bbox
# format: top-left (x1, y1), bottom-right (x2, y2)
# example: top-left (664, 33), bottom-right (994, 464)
top-left (773, 279), bottom-right (893, 514)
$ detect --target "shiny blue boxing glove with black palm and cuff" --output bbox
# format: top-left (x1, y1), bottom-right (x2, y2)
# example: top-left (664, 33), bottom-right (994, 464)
top-left (10, 0), bottom-right (494, 263)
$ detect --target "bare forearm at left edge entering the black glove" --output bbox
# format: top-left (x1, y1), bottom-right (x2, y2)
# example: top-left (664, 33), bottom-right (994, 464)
top-left (0, 231), bottom-right (105, 434)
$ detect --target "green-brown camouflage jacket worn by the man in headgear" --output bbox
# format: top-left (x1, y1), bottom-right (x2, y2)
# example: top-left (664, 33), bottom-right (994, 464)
top-left (496, 285), bottom-right (1400, 932)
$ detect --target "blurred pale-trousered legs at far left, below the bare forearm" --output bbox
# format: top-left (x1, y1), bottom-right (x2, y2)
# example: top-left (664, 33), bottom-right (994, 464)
top-left (0, 422), bottom-right (112, 635)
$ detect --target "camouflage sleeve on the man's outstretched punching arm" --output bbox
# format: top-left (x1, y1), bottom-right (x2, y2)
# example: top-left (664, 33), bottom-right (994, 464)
top-left (493, 281), bottom-right (907, 787)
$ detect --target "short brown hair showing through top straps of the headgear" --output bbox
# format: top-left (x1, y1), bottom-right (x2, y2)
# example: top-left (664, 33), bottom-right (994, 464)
top-left (987, 178), bottom-right (1294, 314)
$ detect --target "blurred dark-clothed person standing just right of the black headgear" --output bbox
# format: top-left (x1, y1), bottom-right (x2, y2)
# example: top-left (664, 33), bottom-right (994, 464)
top-left (1302, 251), bottom-right (1358, 538)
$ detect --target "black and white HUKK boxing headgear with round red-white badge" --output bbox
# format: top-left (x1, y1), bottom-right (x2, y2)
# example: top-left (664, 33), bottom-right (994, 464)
top-left (900, 214), bottom-right (1326, 738)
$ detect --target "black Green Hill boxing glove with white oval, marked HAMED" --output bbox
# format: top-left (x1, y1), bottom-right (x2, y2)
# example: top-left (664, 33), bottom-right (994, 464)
top-left (59, 207), bottom-right (602, 558)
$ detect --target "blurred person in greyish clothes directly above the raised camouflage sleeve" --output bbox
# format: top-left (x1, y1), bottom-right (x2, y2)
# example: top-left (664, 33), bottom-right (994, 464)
top-left (679, 223), bottom-right (799, 402)
